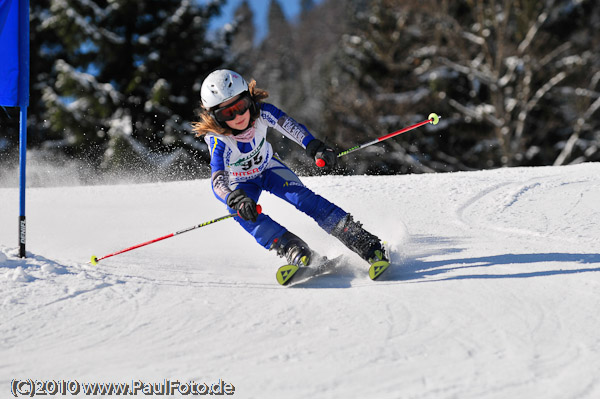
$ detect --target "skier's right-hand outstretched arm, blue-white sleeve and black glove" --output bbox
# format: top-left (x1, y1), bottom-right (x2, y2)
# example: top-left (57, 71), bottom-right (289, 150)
top-left (261, 103), bottom-right (337, 168)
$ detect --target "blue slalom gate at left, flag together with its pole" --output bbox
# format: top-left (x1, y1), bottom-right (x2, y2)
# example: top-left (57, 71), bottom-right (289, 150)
top-left (0, 0), bottom-right (29, 258)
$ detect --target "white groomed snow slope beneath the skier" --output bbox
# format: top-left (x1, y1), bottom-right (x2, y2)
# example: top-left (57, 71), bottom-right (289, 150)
top-left (0, 163), bottom-right (600, 399)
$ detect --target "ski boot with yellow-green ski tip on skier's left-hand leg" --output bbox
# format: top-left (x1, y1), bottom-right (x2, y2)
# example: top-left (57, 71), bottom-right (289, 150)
top-left (270, 231), bottom-right (313, 285)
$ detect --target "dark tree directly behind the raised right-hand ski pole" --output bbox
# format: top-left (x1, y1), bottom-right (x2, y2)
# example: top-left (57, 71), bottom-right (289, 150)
top-left (325, 0), bottom-right (450, 173)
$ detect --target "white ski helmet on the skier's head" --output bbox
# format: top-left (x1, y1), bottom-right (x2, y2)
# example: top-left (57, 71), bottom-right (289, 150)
top-left (200, 69), bottom-right (248, 109)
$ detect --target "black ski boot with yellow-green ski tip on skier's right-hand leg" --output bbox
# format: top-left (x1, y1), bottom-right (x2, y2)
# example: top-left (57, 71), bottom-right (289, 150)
top-left (331, 214), bottom-right (390, 280)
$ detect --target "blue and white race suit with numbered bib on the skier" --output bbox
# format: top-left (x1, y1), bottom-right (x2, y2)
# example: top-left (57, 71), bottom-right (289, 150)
top-left (205, 103), bottom-right (347, 249)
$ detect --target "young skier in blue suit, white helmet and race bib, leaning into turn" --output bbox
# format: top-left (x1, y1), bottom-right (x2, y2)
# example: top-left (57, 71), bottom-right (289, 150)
top-left (193, 69), bottom-right (388, 282)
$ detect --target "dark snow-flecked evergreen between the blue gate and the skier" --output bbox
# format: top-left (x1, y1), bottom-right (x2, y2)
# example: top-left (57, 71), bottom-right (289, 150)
top-left (43, 0), bottom-right (228, 177)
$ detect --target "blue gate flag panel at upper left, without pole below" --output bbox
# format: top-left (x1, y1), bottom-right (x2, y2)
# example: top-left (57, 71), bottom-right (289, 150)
top-left (0, 0), bottom-right (29, 107)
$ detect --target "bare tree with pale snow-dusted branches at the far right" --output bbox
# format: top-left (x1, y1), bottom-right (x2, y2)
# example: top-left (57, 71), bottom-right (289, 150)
top-left (428, 0), bottom-right (598, 166)
